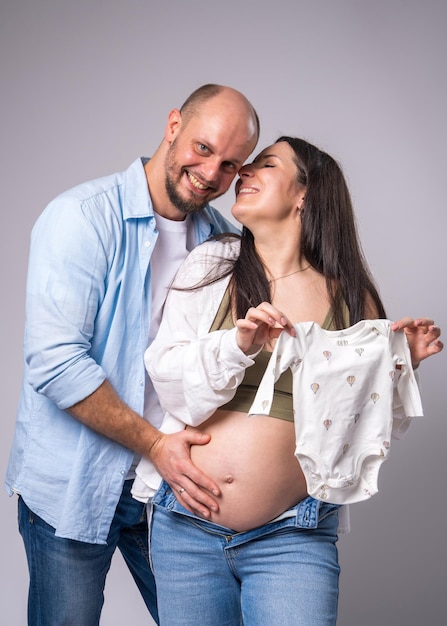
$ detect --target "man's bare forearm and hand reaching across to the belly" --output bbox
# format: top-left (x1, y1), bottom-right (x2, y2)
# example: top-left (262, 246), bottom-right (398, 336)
top-left (67, 381), bottom-right (220, 517)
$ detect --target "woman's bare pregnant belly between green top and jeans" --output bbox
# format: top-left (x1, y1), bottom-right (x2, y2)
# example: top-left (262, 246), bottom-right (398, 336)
top-left (187, 410), bottom-right (307, 531)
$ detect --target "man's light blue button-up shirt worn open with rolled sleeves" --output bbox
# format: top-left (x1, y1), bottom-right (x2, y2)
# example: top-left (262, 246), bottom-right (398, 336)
top-left (6, 159), bottom-right (235, 543)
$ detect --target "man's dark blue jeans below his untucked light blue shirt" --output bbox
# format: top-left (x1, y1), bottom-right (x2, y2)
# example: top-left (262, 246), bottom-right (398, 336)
top-left (19, 480), bottom-right (158, 626)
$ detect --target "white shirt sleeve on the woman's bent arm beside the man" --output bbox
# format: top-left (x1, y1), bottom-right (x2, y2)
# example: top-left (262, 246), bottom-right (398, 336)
top-left (144, 239), bottom-right (254, 426)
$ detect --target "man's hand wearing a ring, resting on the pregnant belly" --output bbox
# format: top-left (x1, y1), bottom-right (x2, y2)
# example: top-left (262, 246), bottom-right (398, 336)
top-left (150, 430), bottom-right (220, 518)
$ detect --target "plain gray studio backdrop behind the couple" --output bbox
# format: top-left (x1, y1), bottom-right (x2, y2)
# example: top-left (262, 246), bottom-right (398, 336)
top-left (0, 0), bottom-right (447, 626)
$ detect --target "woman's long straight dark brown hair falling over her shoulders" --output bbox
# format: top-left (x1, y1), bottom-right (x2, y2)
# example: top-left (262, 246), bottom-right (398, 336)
top-left (231, 136), bottom-right (386, 329)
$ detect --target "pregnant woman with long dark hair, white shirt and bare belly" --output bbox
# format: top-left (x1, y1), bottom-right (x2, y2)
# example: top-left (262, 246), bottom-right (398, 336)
top-left (134, 137), bottom-right (442, 626)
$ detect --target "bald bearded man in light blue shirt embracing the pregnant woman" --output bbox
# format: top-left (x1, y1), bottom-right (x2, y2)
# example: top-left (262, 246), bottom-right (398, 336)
top-left (6, 85), bottom-right (259, 626)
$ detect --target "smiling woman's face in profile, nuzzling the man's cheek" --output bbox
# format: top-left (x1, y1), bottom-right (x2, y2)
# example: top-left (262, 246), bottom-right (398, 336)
top-left (231, 141), bottom-right (305, 230)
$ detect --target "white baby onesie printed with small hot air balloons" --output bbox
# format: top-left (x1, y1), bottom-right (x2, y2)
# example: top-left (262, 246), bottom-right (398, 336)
top-left (249, 320), bottom-right (423, 504)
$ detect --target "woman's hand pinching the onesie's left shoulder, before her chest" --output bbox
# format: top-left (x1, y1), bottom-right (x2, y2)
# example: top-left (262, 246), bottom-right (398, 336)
top-left (236, 302), bottom-right (296, 354)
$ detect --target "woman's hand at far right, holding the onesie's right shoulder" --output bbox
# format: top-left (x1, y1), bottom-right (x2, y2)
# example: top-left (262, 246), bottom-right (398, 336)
top-left (391, 317), bottom-right (444, 368)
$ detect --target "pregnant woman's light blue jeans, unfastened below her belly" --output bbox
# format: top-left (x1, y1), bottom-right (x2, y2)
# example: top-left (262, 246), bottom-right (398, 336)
top-left (150, 482), bottom-right (340, 626)
